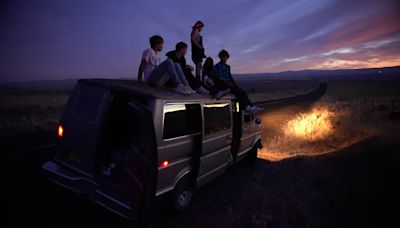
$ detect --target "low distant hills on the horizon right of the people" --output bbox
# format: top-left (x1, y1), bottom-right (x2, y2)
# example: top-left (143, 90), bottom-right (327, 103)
top-left (235, 66), bottom-right (400, 81)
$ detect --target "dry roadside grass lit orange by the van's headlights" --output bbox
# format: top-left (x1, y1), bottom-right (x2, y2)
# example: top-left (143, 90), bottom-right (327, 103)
top-left (259, 81), bottom-right (400, 160)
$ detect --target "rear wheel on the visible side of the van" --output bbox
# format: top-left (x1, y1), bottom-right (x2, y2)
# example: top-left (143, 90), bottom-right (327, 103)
top-left (172, 176), bottom-right (194, 212)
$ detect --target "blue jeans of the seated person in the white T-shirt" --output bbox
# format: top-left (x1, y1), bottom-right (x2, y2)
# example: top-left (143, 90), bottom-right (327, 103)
top-left (147, 59), bottom-right (188, 87)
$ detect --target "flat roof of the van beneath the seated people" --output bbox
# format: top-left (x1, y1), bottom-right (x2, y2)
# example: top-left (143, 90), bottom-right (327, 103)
top-left (78, 78), bottom-right (234, 100)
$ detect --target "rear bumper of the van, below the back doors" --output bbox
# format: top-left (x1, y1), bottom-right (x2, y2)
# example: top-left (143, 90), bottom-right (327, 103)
top-left (42, 161), bottom-right (137, 219)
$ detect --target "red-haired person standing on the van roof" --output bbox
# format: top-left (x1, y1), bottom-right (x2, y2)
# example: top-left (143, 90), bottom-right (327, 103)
top-left (190, 21), bottom-right (206, 82)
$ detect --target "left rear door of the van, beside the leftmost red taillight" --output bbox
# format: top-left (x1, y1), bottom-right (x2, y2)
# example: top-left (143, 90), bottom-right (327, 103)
top-left (56, 82), bottom-right (110, 177)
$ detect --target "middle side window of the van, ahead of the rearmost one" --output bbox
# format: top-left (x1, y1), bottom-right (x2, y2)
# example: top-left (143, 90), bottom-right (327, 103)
top-left (204, 103), bottom-right (231, 134)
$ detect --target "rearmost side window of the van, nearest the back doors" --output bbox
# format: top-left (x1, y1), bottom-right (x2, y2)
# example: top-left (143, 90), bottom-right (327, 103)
top-left (163, 104), bottom-right (201, 139)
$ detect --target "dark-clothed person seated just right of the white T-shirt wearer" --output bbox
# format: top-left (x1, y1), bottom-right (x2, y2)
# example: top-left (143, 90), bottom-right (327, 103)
top-left (166, 42), bottom-right (226, 99)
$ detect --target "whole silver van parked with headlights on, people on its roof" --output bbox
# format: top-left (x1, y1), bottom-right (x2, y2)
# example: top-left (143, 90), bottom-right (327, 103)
top-left (43, 79), bottom-right (262, 219)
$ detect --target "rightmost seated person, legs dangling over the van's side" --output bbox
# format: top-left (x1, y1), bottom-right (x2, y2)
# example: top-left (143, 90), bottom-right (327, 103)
top-left (208, 49), bottom-right (263, 113)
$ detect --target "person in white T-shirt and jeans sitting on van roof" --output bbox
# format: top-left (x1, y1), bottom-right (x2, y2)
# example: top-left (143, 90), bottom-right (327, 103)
top-left (138, 35), bottom-right (193, 95)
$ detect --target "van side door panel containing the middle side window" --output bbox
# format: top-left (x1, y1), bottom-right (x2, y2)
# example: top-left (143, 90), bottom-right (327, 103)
top-left (197, 102), bottom-right (232, 185)
